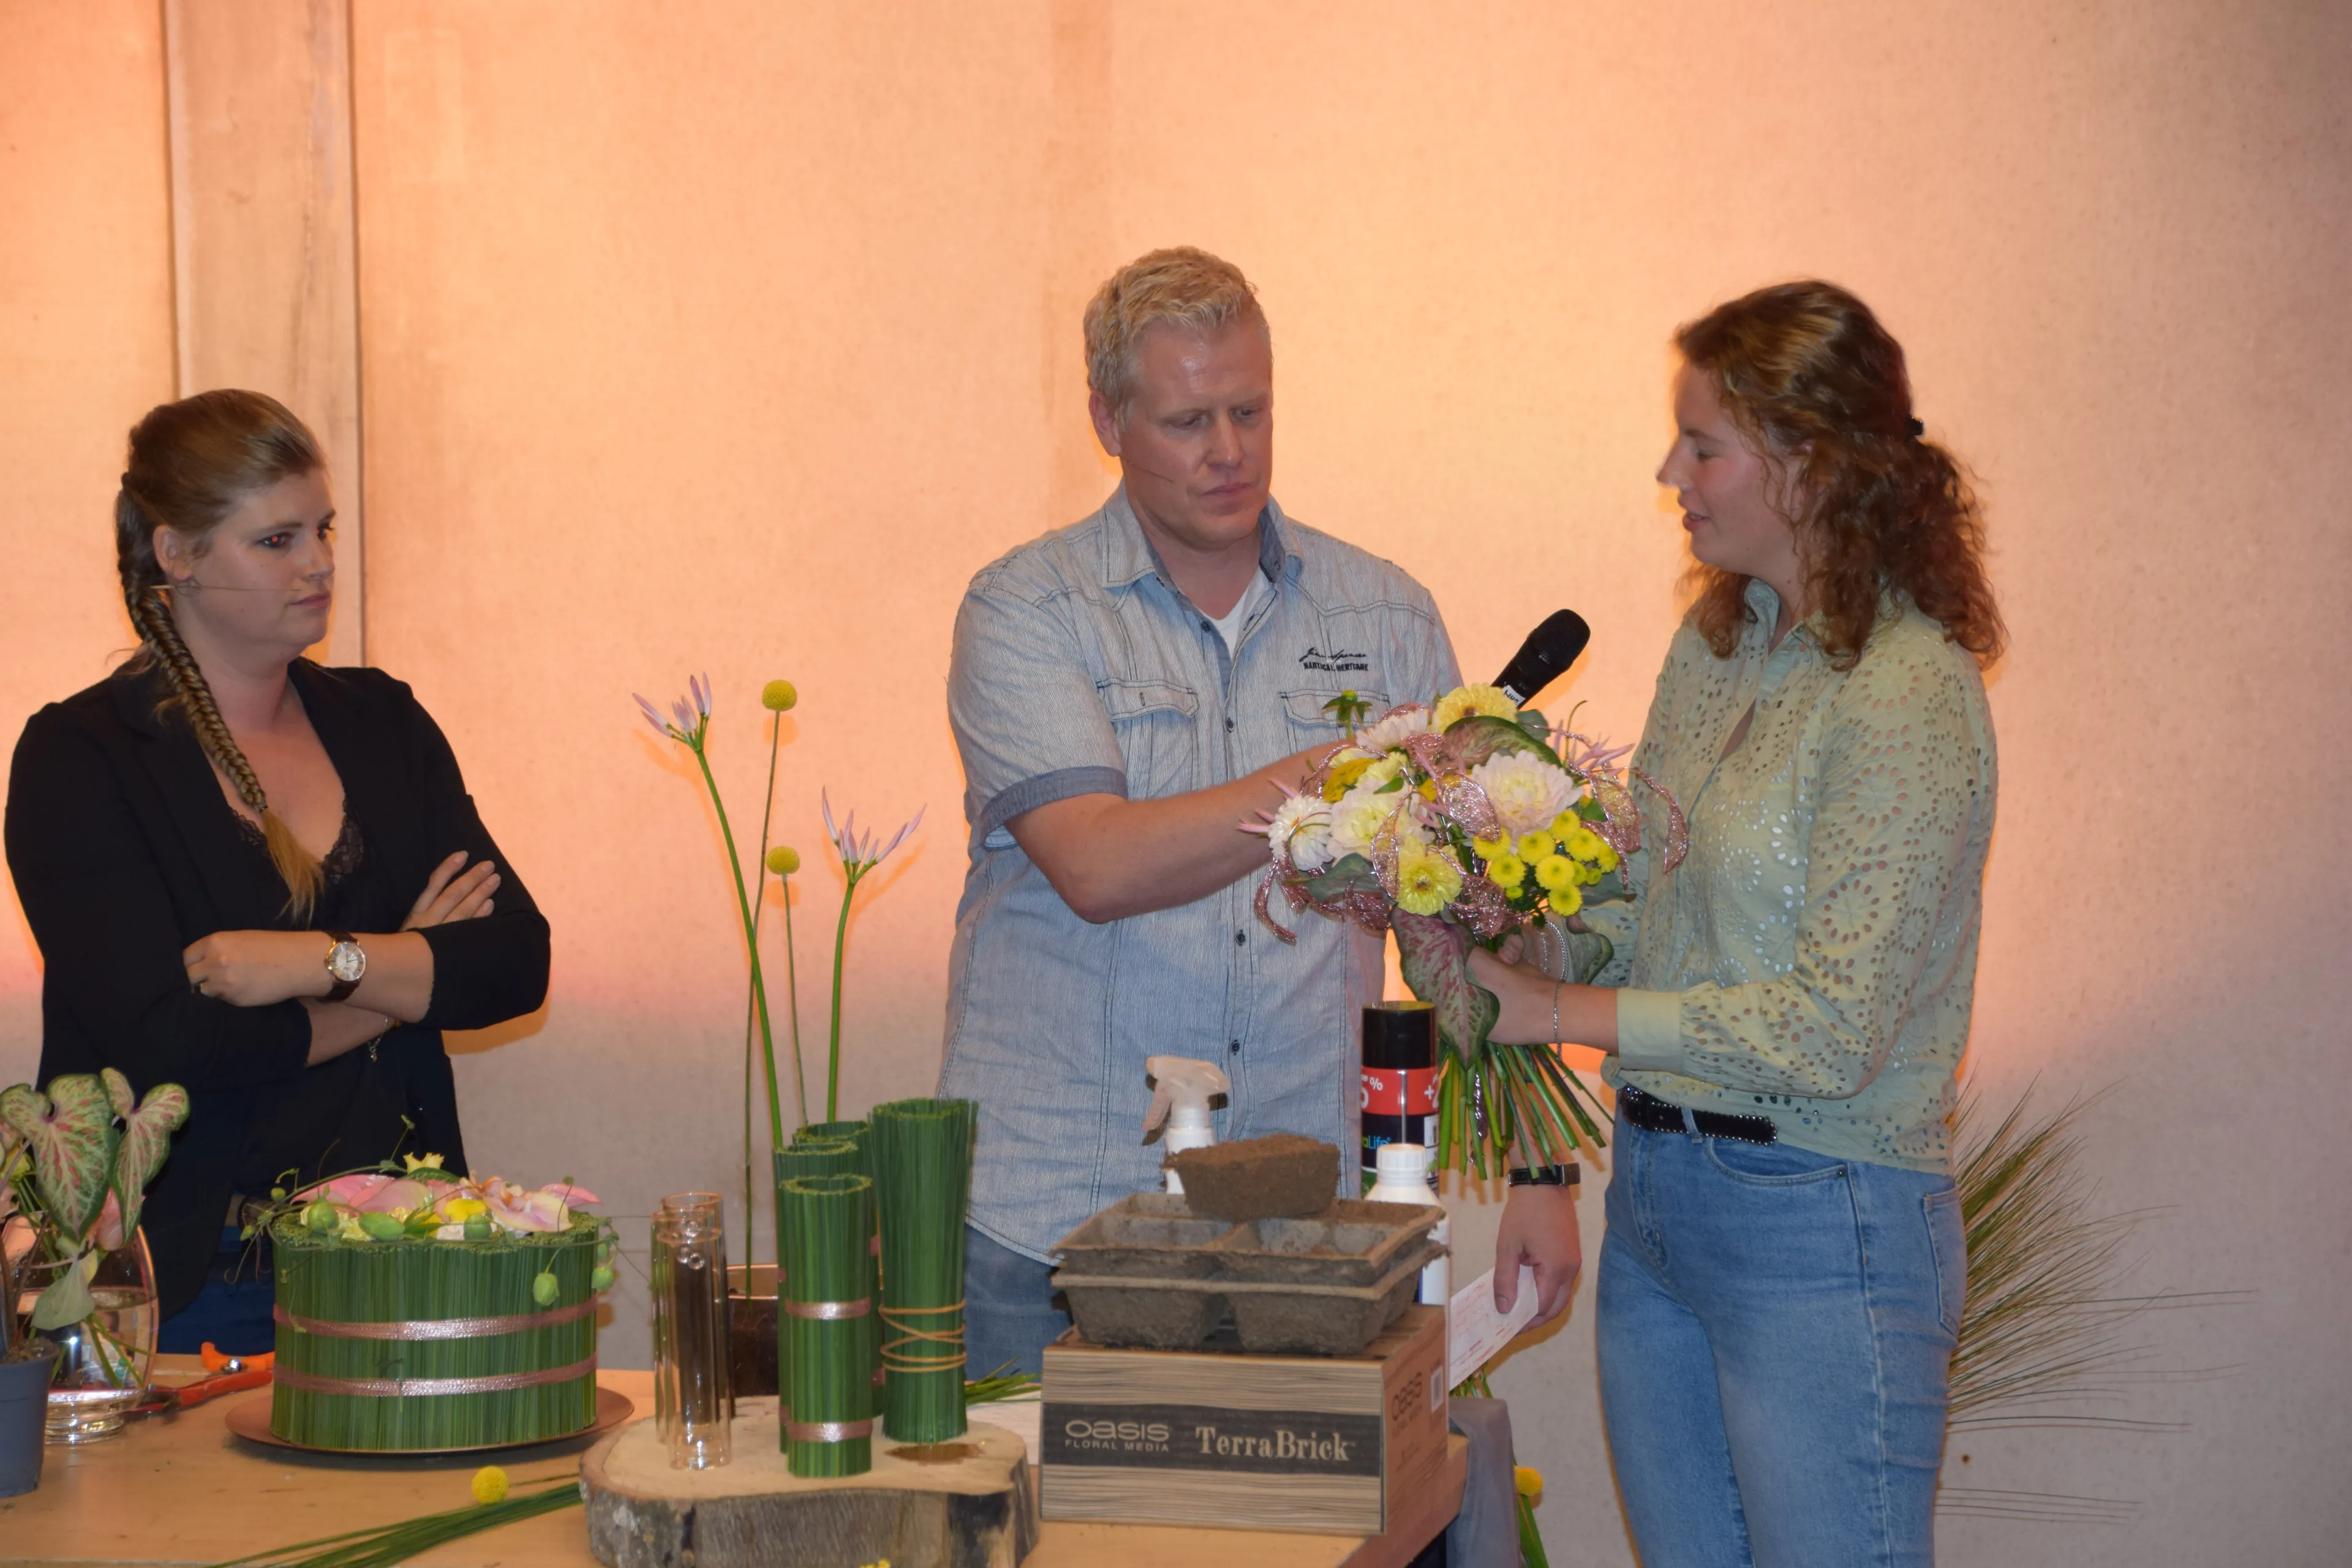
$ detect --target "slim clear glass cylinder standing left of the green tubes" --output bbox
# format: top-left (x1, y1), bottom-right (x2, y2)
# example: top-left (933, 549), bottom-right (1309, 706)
top-left (654, 1192), bottom-right (734, 1469)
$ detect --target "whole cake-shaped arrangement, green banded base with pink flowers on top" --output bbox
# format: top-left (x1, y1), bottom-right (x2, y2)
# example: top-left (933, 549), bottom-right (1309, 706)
top-left (263, 1154), bottom-right (611, 1453)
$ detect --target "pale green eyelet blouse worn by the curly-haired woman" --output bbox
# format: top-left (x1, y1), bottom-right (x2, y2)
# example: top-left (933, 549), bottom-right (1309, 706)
top-left (1585, 581), bottom-right (1999, 1170)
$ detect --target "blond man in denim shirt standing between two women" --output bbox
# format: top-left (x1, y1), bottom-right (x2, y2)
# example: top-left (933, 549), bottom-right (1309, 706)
top-left (941, 249), bottom-right (1458, 1371)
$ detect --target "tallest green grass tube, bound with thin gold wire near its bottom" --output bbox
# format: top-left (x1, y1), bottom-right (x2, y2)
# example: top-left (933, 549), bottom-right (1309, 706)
top-left (873, 1100), bottom-right (974, 1444)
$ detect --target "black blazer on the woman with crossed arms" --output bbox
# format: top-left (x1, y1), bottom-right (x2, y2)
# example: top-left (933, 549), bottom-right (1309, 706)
top-left (7, 661), bottom-right (548, 1316)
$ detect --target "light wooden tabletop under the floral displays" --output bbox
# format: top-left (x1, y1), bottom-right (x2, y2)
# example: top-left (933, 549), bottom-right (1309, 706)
top-left (0, 1357), bottom-right (1468, 1568)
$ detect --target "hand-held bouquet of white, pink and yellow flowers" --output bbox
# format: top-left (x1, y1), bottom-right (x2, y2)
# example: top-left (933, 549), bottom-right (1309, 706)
top-left (1244, 687), bottom-right (1684, 1178)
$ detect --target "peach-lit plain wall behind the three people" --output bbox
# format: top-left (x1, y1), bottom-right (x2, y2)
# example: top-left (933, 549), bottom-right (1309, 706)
top-left (0, 0), bottom-right (2352, 1566)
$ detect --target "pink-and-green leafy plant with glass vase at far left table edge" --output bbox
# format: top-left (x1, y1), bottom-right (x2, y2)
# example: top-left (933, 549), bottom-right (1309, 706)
top-left (0, 1067), bottom-right (188, 1444)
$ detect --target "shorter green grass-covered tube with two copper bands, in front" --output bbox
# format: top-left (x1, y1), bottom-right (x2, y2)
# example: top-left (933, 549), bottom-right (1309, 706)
top-left (776, 1173), bottom-right (875, 1476)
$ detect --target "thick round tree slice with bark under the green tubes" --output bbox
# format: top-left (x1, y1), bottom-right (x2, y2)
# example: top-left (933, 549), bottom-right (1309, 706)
top-left (581, 1399), bottom-right (1037, 1568)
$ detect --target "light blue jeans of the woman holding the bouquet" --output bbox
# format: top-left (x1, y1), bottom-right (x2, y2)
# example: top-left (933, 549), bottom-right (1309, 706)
top-left (1595, 1121), bottom-right (1966, 1568)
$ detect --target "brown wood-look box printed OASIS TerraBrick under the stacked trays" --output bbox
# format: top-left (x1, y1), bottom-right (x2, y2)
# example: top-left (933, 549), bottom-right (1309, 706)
top-left (1037, 1307), bottom-right (1449, 1535)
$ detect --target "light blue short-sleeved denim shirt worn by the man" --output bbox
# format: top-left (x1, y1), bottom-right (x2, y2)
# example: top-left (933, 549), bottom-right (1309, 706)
top-left (941, 489), bottom-right (1461, 1260)
